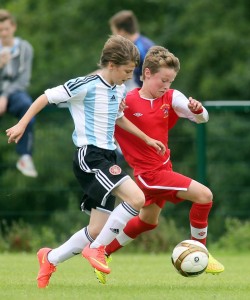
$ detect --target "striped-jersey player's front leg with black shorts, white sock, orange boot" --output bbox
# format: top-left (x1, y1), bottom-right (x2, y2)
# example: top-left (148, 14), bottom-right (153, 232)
top-left (77, 145), bottom-right (145, 273)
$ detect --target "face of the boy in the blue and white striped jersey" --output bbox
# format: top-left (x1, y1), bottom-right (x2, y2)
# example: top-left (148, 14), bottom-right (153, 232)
top-left (109, 62), bottom-right (135, 85)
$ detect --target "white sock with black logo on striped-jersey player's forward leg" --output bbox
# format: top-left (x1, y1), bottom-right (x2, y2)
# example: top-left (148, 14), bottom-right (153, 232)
top-left (90, 202), bottom-right (139, 248)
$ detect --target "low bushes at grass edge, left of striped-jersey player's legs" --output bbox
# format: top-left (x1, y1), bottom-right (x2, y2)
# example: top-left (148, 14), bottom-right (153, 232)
top-left (0, 210), bottom-right (88, 253)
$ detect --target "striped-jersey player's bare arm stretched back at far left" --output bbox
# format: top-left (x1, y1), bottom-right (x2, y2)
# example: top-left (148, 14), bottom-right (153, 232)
top-left (6, 94), bottom-right (48, 143)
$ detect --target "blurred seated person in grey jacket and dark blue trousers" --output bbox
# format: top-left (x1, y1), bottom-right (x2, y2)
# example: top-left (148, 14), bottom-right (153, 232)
top-left (0, 9), bottom-right (38, 177)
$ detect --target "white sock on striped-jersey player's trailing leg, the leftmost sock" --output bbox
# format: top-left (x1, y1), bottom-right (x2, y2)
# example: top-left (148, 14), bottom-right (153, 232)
top-left (48, 227), bottom-right (93, 266)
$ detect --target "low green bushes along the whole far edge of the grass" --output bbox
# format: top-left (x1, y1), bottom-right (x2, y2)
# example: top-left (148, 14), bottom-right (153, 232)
top-left (0, 211), bottom-right (250, 254)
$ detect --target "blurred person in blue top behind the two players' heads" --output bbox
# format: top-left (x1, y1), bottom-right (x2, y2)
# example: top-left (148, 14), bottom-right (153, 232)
top-left (109, 10), bottom-right (155, 90)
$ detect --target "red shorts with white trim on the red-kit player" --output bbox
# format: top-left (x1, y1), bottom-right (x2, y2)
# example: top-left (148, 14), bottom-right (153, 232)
top-left (135, 161), bottom-right (192, 208)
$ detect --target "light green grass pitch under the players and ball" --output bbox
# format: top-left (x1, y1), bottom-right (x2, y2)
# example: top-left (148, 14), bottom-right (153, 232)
top-left (0, 253), bottom-right (250, 300)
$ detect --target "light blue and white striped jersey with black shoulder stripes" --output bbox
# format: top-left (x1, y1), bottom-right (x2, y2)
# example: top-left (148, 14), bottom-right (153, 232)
top-left (45, 75), bottom-right (126, 150)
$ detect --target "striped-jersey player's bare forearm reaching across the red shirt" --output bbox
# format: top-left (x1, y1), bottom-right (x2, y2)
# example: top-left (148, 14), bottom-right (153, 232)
top-left (116, 116), bottom-right (166, 155)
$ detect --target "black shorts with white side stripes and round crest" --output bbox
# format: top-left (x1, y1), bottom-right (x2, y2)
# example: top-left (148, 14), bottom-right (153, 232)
top-left (73, 145), bottom-right (129, 211)
